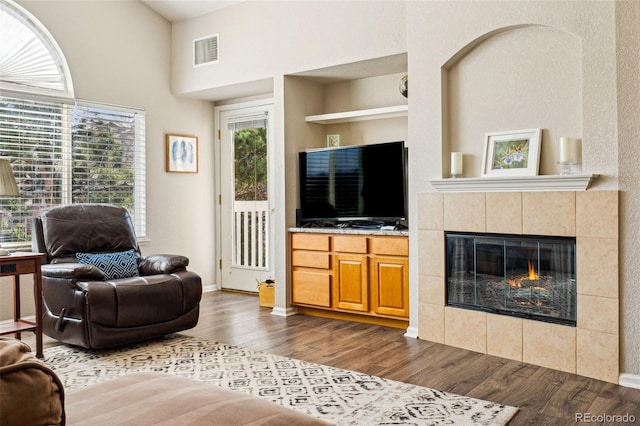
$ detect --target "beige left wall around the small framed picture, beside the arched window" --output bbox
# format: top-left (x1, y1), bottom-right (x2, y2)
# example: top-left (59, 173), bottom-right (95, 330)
top-left (1, 0), bottom-right (216, 318)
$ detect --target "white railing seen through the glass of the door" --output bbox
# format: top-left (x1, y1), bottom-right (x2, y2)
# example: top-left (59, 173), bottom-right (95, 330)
top-left (233, 201), bottom-right (269, 269)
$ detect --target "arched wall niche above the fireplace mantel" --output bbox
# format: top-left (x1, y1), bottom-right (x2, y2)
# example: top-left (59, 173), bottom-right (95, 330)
top-left (442, 25), bottom-right (583, 177)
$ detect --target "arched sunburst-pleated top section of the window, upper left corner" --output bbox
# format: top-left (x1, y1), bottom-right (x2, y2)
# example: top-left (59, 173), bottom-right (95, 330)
top-left (0, 0), bottom-right (73, 98)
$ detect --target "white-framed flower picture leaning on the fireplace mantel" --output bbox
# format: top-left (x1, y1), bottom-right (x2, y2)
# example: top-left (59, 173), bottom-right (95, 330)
top-left (482, 129), bottom-right (542, 177)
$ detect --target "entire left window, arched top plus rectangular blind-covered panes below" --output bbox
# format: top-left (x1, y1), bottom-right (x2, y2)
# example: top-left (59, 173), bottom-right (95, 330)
top-left (0, 0), bottom-right (146, 249)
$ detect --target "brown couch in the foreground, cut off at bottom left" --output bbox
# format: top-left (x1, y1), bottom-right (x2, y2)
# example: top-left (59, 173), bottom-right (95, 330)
top-left (0, 337), bottom-right (336, 426)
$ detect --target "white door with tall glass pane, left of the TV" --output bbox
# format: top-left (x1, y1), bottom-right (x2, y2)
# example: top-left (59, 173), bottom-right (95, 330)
top-left (219, 105), bottom-right (273, 291)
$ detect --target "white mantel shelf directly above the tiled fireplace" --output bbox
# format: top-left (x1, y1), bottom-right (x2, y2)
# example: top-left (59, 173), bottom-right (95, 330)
top-left (428, 174), bottom-right (599, 192)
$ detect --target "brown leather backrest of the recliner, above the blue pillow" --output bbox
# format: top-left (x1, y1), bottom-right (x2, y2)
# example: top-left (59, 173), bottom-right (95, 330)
top-left (33, 204), bottom-right (140, 263)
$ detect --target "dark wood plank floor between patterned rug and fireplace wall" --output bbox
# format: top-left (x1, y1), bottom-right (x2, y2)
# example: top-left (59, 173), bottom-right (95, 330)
top-left (35, 291), bottom-right (640, 425)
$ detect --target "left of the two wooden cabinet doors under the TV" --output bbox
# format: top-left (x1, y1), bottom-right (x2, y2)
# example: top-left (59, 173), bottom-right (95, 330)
top-left (334, 254), bottom-right (369, 312)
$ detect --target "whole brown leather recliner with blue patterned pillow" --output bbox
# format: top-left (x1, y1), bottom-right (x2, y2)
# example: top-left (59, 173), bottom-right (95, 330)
top-left (32, 204), bottom-right (202, 349)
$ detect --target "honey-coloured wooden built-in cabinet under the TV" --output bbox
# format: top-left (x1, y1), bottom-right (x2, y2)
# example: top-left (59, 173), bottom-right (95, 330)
top-left (290, 228), bottom-right (409, 328)
